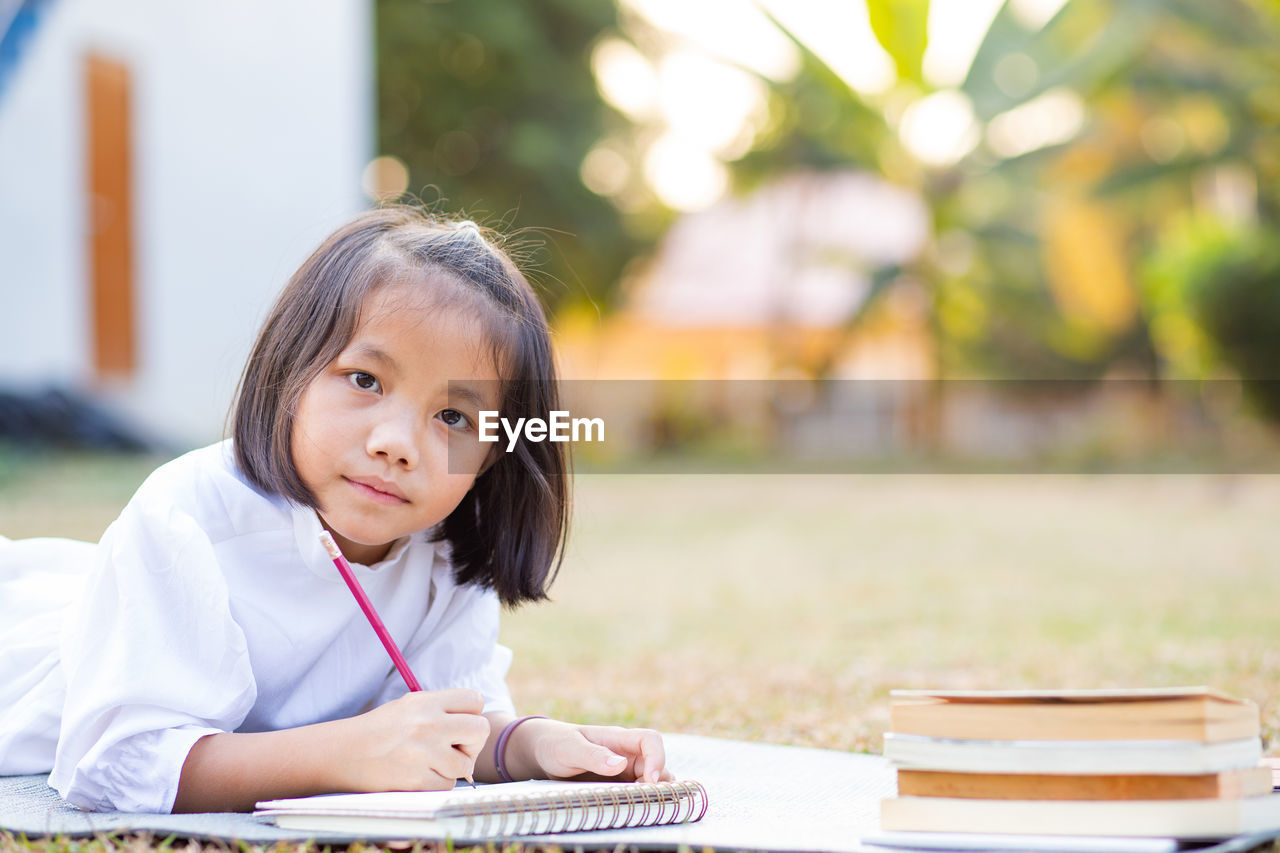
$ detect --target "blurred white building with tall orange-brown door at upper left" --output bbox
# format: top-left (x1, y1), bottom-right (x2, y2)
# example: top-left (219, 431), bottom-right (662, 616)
top-left (0, 0), bottom-right (374, 444)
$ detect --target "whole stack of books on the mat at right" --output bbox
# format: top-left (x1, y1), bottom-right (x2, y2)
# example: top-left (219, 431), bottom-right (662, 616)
top-left (881, 688), bottom-right (1280, 839)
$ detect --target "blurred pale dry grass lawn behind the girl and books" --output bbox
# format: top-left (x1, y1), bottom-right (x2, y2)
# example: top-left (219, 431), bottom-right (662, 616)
top-left (0, 448), bottom-right (1280, 853)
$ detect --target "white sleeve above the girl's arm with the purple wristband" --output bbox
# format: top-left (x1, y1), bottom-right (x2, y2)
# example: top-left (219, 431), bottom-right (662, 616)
top-left (374, 585), bottom-right (516, 713)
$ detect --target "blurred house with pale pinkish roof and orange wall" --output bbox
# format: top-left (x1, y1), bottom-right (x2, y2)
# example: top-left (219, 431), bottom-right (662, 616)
top-left (558, 170), bottom-right (934, 379)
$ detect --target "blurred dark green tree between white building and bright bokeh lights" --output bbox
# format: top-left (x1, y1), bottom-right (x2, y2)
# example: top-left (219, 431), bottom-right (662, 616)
top-left (376, 0), bottom-right (636, 307)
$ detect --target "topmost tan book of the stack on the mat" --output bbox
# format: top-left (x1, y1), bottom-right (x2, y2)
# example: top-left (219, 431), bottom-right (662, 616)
top-left (890, 686), bottom-right (1260, 742)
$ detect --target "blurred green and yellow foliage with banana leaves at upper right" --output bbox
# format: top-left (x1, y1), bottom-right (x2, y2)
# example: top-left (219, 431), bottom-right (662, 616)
top-left (732, 0), bottom-right (1280, 394)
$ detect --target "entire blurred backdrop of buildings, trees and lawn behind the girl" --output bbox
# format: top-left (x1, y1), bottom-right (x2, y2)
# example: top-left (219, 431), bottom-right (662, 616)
top-left (0, 0), bottom-right (1280, 747)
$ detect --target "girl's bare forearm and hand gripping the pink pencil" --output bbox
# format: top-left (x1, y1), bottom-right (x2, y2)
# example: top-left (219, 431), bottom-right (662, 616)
top-left (173, 689), bottom-right (489, 812)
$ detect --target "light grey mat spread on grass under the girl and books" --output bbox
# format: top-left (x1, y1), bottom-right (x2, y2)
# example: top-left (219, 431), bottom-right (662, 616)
top-left (0, 735), bottom-right (895, 853)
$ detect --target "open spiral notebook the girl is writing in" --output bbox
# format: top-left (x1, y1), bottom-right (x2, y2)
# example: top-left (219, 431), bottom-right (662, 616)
top-left (255, 781), bottom-right (707, 839)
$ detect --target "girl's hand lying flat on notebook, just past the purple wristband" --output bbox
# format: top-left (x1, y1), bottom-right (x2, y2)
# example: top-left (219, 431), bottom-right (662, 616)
top-left (527, 720), bottom-right (675, 781)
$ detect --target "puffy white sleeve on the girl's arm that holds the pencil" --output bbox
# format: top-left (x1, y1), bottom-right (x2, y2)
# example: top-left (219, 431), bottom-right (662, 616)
top-left (50, 501), bottom-right (256, 812)
